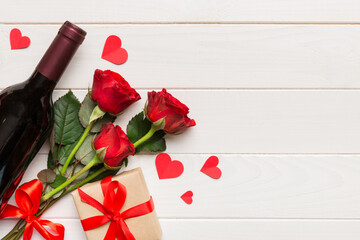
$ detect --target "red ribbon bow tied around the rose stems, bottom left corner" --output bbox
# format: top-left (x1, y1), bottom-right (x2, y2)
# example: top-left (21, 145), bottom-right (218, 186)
top-left (0, 179), bottom-right (65, 240)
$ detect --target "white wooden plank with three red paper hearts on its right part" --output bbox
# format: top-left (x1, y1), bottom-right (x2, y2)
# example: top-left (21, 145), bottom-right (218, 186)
top-left (6, 154), bottom-right (360, 219)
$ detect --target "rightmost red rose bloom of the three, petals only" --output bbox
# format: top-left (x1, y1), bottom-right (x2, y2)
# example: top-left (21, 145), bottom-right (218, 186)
top-left (145, 88), bottom-right (196, 133)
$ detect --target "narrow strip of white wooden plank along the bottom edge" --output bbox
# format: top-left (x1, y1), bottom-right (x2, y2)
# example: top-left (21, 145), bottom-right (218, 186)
top-left (0, 218), bottom-right (360, 240)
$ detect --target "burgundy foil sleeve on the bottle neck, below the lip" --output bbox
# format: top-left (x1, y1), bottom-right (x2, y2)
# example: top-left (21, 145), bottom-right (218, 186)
top-left (35, 32), bottom-right (80, 83)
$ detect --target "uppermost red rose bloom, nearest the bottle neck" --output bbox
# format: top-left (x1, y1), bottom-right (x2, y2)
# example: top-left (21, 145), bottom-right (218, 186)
top-left (91, 69), bottom-right (140, 115)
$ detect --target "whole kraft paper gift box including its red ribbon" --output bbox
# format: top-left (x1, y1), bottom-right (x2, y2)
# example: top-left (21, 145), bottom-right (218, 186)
top-left (72, 168), bottom-right (162, 240)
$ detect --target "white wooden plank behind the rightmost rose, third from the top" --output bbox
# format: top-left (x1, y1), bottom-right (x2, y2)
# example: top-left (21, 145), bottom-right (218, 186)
top-left (35, 90), bottom-right (360, 153)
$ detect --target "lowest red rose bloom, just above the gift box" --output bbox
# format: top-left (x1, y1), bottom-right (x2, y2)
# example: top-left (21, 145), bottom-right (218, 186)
top-left (93, 123), bottom-right (135, 168)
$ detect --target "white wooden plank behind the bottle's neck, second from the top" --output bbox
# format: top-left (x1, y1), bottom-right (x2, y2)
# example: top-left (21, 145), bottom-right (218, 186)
top-left (0, 24), bottom-right (360, 89)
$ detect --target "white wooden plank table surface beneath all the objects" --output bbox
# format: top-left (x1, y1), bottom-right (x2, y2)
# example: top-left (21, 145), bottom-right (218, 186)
top-left (0, 0), bottom-right (360, 240)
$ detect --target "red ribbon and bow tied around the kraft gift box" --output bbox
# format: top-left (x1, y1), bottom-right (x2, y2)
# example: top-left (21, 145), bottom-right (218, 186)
top-left (78, 176), bottom-right (154, 240)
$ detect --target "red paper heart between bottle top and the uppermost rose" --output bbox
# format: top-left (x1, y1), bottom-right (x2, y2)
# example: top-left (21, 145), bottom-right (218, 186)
top-left (101, 35), bottom-right (128, 65)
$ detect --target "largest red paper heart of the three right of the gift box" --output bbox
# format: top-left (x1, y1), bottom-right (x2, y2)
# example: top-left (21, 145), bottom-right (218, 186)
top-left (155, 153), bottom-right (184, 179)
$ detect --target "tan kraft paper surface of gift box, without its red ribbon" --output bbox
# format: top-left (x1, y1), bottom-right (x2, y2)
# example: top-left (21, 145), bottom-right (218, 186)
top-left (72, 168), bottom-right (162, 240)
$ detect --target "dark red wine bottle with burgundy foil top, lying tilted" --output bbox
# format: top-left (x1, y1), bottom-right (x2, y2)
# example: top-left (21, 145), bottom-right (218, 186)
top-left (0, 21), bottom-right (86, 214)
